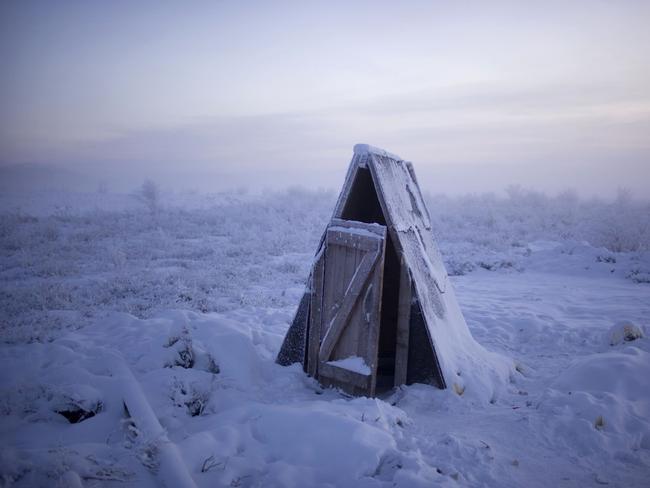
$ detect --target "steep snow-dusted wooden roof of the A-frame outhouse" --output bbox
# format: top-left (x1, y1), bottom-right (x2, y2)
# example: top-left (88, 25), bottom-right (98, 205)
top-left (281, 144), bottom-right (511, 396)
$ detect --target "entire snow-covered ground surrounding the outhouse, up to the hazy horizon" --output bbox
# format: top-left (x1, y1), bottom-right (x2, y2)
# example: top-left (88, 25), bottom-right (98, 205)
top-left (0, 190), bottom-right (650, 487)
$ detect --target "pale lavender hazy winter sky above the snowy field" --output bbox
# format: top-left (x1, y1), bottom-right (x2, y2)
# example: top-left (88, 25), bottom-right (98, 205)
top-left (0, 0), bottom-right (650, 195)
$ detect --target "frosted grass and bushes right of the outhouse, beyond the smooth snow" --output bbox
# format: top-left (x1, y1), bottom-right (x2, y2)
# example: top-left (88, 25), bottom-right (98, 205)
top-left (427, 187), bottom-right (650, 276)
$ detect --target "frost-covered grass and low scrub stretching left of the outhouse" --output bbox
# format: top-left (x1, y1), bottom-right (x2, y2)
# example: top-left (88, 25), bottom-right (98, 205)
top-left (0, 189), bottom-right (335, 342)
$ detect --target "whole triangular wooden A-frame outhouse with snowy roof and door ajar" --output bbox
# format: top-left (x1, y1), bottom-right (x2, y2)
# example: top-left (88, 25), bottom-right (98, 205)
top-left (277, 145), bottom-right (473, 396)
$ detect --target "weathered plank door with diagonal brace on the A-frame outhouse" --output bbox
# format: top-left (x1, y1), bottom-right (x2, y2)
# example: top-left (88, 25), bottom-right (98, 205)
top-left (308, 219), bottom-right (386, 396)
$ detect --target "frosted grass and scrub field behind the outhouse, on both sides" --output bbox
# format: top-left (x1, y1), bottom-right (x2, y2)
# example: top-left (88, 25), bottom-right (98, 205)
top-left (0, 187), bottom-right (650, 342)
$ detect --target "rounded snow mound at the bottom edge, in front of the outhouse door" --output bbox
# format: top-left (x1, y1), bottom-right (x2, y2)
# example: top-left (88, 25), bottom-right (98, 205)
top-left (180, 399), bottom-right (404, 487)
